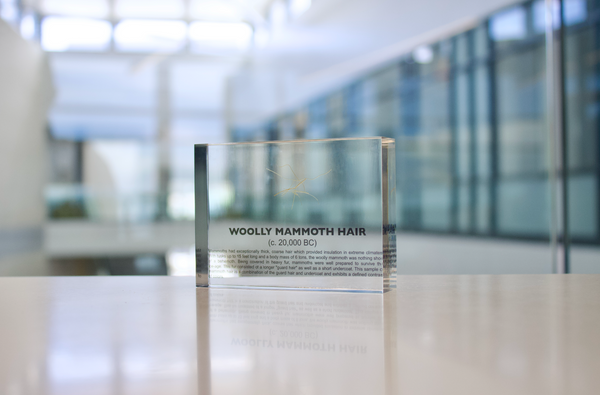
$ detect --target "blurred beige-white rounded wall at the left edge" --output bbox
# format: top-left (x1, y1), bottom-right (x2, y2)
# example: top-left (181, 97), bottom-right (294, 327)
top-left (0, 20), bottom-right (53, 275)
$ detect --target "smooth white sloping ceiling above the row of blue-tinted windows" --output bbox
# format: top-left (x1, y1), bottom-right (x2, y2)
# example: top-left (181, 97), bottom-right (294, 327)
top-left (226, 0), bottom-right (516, 123)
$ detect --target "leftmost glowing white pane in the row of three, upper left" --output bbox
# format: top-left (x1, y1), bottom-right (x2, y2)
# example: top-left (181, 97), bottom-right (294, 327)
top-left (41, 16), bottom-right (112, 52)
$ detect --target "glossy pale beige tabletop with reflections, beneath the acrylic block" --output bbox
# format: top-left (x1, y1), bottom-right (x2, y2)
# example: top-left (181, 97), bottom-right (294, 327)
top-left (0, 275), bottom-right (600, 395)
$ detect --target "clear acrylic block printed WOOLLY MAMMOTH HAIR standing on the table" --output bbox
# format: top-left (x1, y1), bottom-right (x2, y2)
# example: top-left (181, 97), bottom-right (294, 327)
top-left (195, 137), bottom-right (396, 292)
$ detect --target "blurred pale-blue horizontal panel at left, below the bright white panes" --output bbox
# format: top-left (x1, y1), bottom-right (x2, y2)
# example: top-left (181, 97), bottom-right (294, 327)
top-left (50, 111), bottom-right (156, 140)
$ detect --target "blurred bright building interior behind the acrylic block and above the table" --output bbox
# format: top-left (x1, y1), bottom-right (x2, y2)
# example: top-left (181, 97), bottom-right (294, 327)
top-left (0, 0), bottom-right (600, 275)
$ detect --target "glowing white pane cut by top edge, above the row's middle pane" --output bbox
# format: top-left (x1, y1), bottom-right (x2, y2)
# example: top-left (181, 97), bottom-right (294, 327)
top-left (115, 0), bottom-right (185, 18)
